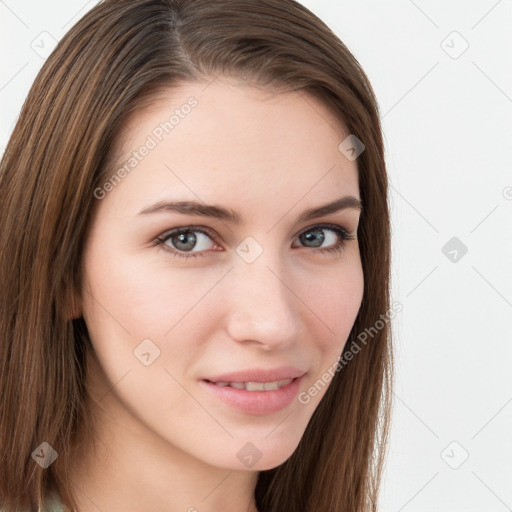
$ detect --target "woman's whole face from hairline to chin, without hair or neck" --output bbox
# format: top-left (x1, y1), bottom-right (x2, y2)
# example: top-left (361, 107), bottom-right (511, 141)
top-left (79, 80), bottom-right (363, 470)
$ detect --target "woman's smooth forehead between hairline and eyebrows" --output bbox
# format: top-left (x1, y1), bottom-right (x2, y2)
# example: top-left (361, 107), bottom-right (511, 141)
top-left (98, 80), bottom-right (359, 218)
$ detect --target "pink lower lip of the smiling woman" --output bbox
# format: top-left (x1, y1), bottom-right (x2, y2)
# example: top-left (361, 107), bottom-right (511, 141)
top-left (201, 375), bottom-right (304, 415)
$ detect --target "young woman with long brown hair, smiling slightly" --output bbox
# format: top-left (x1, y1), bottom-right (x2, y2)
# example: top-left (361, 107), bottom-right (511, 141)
top-left (0, 0), bottom-right (392, 512)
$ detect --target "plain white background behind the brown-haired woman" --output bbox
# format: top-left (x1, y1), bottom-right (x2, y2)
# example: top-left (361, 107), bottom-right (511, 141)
top-left (0, 0), bottom-right (512, 512)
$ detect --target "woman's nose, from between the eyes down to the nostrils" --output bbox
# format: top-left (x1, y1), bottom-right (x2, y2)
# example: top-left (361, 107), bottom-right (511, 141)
top-left (223, 251), bottom-right (304, 350)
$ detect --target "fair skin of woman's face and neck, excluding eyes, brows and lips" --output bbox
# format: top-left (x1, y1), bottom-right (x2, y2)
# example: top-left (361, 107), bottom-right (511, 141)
top-left (71, 79), bottom-right (363, 512)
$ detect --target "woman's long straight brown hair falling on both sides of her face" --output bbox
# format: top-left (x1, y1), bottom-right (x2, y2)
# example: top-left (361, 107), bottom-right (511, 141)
top-left (0, 0), bottom-right (393, 512)
